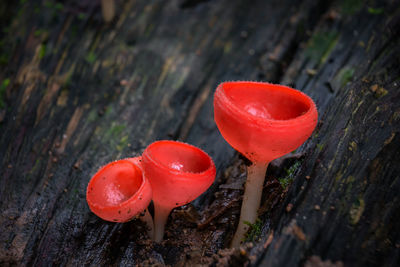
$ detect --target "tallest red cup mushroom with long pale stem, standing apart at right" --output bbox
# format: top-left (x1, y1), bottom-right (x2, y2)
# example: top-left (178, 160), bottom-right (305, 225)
top-left (214, 82), bottom-right (318, 247)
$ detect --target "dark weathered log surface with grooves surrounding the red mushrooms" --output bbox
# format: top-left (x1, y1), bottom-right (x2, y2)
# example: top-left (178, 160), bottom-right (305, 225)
top-left (0, 0), bottom-right (400, 266)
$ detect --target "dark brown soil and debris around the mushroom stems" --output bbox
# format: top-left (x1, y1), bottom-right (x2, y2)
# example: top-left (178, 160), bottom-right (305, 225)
top-left (120, 155), bottom-right (292, 266)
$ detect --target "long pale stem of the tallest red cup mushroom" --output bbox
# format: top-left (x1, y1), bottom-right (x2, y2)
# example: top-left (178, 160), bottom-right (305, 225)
top-left (231, 162), bottom-right (268, 248)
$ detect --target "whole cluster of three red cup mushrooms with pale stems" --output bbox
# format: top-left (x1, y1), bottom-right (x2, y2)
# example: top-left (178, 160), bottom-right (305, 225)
top-left (86, 82), bottom-right (318, 247)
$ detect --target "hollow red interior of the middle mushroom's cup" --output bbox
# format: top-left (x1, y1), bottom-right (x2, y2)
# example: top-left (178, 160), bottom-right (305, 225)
top-left (151, 142), bottom-right (210, 173)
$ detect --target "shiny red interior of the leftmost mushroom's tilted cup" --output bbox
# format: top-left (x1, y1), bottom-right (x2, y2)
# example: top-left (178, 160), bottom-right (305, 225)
top-left (89, 162), bottom-right (143, 206)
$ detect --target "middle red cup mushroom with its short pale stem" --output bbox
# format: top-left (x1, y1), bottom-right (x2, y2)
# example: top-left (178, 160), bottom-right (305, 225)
top-left (142, 141), bottom-right (216, 242)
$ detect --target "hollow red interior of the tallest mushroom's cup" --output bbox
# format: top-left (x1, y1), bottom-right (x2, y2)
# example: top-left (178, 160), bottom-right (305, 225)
top-left (223, 83), bottom-right (310, 120)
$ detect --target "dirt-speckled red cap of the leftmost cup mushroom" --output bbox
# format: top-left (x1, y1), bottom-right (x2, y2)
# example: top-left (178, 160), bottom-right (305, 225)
top-left (86, 159), bottom-right (152, 222)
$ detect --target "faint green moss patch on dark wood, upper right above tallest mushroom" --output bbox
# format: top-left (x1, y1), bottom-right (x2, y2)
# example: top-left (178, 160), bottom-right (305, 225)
top-left (305, 32), bottom-right (339, 63)
